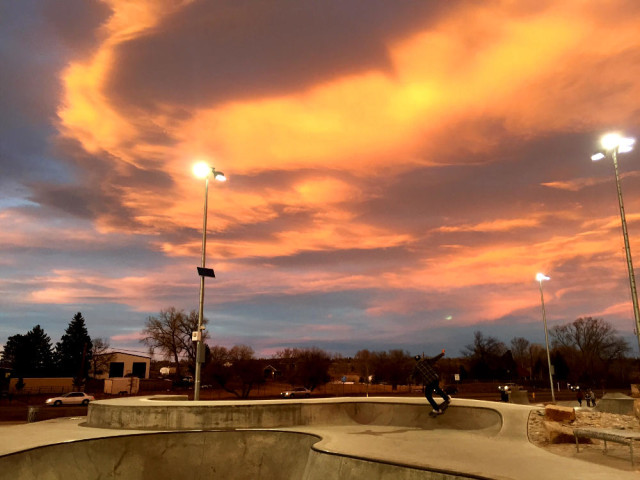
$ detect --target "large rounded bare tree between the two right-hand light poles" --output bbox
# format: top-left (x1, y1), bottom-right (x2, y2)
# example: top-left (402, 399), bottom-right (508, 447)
top-left (549, 317), bottom-right (629, 381)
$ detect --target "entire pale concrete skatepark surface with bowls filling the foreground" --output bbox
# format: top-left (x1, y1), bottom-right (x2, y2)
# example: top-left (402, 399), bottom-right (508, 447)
top-left (0, 397), bottom-right (638, 480)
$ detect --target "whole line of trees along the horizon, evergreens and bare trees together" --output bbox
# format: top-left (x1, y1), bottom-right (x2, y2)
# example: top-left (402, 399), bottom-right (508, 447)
top-left (2, 307), bottom-right (638, 398)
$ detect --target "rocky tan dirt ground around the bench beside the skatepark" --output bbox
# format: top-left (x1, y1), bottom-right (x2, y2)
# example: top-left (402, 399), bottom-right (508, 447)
top-left (528, 408), bottom-right (640, 471)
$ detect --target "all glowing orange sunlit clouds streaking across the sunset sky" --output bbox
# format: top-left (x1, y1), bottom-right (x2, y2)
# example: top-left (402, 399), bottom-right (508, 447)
top-left (38, 0), bottom-right (640, 334)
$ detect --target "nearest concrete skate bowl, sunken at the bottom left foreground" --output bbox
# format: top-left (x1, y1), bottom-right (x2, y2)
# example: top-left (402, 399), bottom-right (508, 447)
top-left (0, 431), bottom-right (496, 480)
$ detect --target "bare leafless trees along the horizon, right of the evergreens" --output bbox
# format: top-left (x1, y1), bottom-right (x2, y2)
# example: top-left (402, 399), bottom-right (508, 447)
top-left (142, 308), bottom-right (638, 398)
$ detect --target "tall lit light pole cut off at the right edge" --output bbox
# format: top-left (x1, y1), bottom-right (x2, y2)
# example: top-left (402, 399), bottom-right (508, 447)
top-left (591, 133), bottom-right (640, 348)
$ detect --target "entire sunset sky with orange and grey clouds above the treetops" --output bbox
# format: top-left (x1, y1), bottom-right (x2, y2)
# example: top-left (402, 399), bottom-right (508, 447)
top-left (0, 0), bottom-right (640, 356)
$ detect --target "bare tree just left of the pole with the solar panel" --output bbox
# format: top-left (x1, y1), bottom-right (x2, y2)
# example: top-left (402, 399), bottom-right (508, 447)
top-left (140, 307), bottom-right (208, 378)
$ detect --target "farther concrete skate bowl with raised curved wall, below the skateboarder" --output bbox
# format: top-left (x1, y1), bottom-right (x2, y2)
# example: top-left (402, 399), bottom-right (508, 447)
top-left (87, 397), bottom-right (503, 436)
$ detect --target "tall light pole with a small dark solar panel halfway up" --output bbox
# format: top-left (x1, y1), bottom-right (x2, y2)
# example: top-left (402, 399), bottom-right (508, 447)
top-left (193, 162), bottom-right (226, 400)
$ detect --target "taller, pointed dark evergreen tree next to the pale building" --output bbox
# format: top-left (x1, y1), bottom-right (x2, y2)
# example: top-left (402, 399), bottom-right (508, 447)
top-left (56, 312), bottom-right (93, 384)
